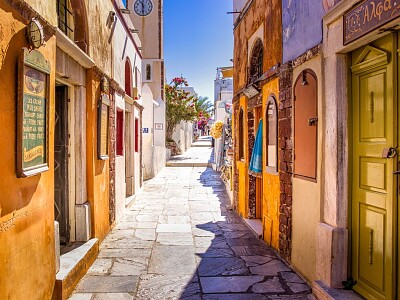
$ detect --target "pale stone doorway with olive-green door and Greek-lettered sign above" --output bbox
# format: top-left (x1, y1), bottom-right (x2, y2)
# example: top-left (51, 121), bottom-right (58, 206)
top-left (316, 0), bottom-right (400, 299)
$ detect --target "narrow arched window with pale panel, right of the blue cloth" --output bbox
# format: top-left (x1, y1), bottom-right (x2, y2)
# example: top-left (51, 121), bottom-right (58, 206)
top-left (265, 95), bottom-right (278, 173)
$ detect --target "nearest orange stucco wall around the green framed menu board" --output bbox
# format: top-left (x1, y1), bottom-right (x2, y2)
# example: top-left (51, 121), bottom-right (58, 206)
top-left (0, 1), bottom-right (56, 299)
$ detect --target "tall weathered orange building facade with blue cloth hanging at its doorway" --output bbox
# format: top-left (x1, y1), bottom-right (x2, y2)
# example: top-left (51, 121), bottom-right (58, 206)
top-left (232, 1), bottom-right (282, 249)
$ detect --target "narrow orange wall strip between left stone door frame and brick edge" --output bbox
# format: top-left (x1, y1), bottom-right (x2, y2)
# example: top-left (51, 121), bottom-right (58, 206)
top-left (86, 70), bottom-right (110, 240)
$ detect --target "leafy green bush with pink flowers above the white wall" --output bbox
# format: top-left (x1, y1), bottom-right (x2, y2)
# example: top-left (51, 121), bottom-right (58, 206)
top-left (165, 77), bottom-right (197, 140)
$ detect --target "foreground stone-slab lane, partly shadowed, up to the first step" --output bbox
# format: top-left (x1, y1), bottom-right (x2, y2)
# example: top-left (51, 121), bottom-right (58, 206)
top-left (70, 167), bottom-right (314, 300)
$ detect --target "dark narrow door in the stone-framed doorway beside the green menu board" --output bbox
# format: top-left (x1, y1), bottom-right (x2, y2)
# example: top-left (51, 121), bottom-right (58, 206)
top-left (54, 86), bottom-right (70, 244)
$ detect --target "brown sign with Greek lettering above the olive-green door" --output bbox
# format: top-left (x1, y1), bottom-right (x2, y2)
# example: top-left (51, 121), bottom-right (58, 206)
top-left (343, 0), bottom-right (400, 45)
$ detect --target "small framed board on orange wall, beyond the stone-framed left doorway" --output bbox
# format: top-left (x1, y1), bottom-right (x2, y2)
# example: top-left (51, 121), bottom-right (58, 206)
top-left (97, 95), bottom-right (110, 160)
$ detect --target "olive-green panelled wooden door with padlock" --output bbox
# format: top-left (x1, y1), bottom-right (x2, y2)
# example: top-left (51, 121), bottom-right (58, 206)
top-left (351, 35), bottom-right (398, 299)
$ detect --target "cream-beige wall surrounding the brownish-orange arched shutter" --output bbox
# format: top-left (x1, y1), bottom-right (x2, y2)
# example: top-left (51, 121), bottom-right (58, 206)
top-left (291, 56), bottom-right (324, 282)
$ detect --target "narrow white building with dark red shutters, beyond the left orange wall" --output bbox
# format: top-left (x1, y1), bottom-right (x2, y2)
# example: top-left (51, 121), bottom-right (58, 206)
top-left (111, 0), bottom-right (143, 222)
